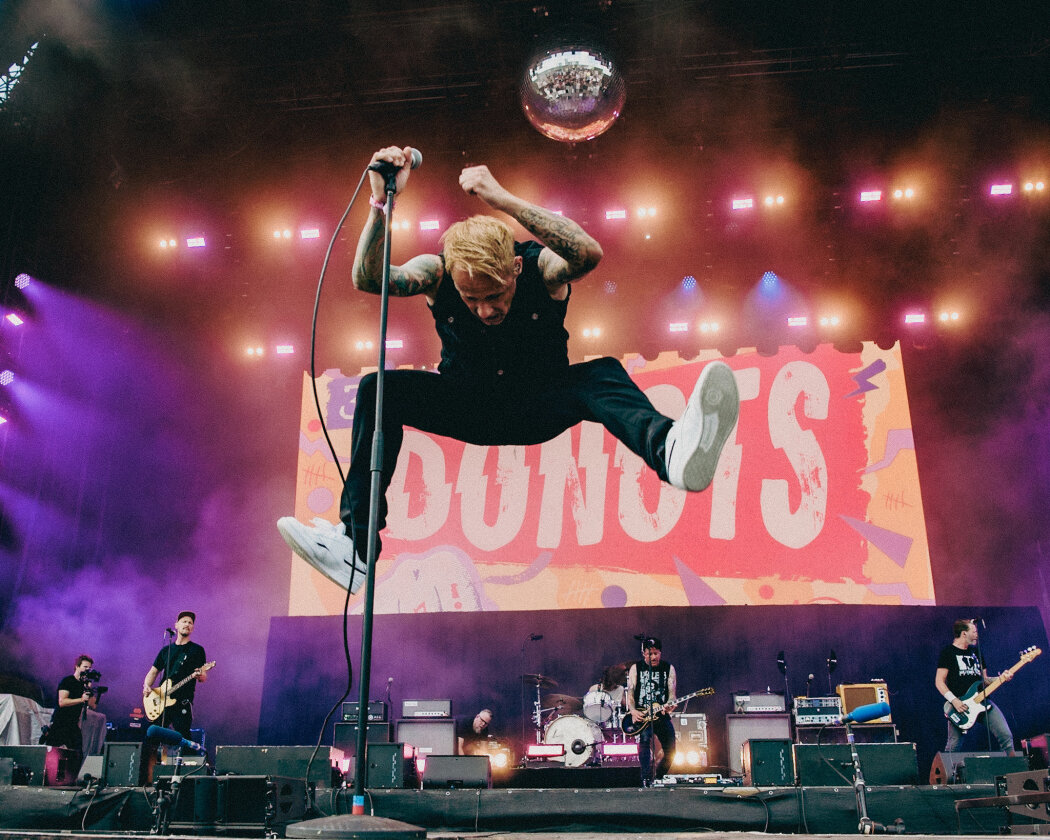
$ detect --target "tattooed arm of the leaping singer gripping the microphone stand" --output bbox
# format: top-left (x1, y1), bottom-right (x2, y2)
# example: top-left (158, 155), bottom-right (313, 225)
top-left (353, 146), bottom-right (443, 302)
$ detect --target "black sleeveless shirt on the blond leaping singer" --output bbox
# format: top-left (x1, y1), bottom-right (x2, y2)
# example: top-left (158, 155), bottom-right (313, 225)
top-left (431, 242), bottom-right (571, 386)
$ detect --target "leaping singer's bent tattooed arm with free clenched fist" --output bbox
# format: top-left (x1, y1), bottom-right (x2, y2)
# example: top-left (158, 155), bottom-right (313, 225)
top-left (460, 166), bottom-right (602, 297)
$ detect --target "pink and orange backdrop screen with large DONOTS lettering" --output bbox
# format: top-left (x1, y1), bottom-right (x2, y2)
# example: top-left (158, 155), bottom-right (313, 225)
top-left (289, 344), bottom-right (933, 615)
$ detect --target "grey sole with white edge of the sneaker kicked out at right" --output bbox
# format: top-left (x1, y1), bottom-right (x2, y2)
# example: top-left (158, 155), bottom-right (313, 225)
top-left (676, 361), bottom-right (740, 492)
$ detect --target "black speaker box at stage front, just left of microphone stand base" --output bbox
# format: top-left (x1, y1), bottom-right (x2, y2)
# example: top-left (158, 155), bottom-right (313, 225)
top-left (215, 772), bottom-right (313, 837)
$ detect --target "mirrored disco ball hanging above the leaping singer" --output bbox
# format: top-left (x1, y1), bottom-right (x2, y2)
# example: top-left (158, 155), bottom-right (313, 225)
top-left (519, 43), bottom-right (627, 143)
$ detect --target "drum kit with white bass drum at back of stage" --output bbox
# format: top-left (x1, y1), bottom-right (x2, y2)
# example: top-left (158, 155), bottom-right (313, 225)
top-left (522, 674), bottom-right (627, 768)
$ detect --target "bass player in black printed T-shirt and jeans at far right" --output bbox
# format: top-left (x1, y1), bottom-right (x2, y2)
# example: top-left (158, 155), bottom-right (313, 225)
top-left (933, 618), bottom-right (1014, 755)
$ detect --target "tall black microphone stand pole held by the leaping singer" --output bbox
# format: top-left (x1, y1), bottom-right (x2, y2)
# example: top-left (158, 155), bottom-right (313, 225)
top-left (352, 170), bottom-right (397, 815)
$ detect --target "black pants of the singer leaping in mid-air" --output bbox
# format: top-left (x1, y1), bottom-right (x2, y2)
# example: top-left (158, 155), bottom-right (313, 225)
top-left (339, 357), bottom-right (672, 559)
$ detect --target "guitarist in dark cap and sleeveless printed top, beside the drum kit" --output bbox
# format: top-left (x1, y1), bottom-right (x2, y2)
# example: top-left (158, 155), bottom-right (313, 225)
top-left (627, 636), bottom-right (677, 788)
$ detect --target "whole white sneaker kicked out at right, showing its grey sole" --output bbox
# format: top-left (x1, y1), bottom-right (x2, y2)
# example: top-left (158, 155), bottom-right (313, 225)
top-left (664, 361), bottom-right (740, 491)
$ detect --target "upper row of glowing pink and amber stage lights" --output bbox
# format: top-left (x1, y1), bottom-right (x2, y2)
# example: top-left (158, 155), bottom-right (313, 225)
top-left (158, 175), bottom-right (1046, 251)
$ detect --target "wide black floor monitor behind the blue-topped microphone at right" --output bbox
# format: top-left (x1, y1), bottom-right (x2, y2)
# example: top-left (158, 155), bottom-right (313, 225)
top-left (794, 742), bottom-right (919, 788)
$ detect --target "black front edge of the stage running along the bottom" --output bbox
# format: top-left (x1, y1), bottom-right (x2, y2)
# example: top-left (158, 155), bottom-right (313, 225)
top-left (0, 776), bottom-right (1033, 837)
